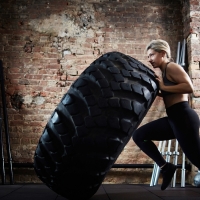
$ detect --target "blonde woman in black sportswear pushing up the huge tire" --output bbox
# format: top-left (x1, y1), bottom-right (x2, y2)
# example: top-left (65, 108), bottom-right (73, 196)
top-left (133, 39), bottom-right (200, 190)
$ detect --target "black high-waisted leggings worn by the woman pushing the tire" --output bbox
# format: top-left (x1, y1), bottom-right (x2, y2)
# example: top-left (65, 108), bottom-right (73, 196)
top-left (133, 101), bottom-right (200, 169)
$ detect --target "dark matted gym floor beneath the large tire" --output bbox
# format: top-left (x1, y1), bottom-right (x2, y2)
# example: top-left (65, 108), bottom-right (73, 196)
top-left (0, 184), bottom-right (200, 200)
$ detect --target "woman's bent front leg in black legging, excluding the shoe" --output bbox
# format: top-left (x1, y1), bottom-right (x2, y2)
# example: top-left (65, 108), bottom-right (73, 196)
top-left (133, 117), bottom-right (175, 167)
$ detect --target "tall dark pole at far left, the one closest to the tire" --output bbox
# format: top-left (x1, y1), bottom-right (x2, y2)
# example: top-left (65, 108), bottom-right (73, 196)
top-left (0, 60), bottom-right (14, 184)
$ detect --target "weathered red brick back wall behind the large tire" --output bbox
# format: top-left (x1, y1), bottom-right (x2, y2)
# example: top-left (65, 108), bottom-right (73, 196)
top-left (0, 0), bottom-right (194, 183)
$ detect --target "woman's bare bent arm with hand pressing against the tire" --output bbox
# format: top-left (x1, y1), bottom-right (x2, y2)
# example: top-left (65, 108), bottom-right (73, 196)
top-left (156, 63), bottom-right (193, 94)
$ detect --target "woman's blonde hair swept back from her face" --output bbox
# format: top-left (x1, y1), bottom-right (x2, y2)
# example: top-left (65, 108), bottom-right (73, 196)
top-left (146, 39), bottom-right (171, 59)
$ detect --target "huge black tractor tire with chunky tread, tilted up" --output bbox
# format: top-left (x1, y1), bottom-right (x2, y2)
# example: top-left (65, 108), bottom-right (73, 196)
top-left (34, 52), bottom-right (158, 200)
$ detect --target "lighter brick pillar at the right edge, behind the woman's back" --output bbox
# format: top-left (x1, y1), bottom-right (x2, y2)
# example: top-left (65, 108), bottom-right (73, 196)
top-left (183, 0), bottom-right (200, 184)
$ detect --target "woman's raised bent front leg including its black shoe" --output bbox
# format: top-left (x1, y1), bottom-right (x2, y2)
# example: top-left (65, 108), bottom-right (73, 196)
top-left (133, 117), bottom-right (176, 190)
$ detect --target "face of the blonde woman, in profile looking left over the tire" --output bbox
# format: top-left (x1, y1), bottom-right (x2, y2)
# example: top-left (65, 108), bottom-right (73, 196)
top-left (147, 49), bottom-right (163, 68)
